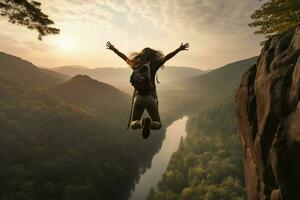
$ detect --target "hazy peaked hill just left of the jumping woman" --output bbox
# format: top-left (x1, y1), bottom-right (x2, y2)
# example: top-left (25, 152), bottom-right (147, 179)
top-left (50, 75), bottom-right (131, 117)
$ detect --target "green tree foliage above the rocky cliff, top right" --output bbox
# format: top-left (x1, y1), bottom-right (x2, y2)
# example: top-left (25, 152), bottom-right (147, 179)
top-left (249, 0), bottom-right (300, 35)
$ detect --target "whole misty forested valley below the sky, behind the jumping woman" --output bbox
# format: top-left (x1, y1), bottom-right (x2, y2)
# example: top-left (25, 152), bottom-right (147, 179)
top-left (0, 53), bottom-right (257, 200)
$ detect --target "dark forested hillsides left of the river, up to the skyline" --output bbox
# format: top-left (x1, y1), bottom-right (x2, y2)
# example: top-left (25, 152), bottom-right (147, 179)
top-left (0, 53), bottom-right (171, 200)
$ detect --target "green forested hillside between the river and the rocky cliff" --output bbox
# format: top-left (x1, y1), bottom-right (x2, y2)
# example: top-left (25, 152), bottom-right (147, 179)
top-left (147, 57), bottom-right (258, 200)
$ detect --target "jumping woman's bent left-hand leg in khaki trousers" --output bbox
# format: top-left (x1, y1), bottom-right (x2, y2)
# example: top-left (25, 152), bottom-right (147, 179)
top-left (130, 95), bottom-right (145, 129)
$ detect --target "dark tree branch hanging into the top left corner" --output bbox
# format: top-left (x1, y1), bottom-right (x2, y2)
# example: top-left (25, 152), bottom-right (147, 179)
top-left (0, 0), bottom-right (59, 40)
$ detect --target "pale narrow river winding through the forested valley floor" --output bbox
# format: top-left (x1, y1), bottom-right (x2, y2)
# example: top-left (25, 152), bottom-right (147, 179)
top-left (129, 117), bottom-right (188, 200)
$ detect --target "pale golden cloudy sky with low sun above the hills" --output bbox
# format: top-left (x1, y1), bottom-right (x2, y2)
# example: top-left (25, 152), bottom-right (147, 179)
top-left (0, 0), bottom-right (263, 70)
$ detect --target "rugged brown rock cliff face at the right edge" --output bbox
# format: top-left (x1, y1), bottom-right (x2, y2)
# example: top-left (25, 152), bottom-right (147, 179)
top-left (236, 27), bottom-right (300, 200)
